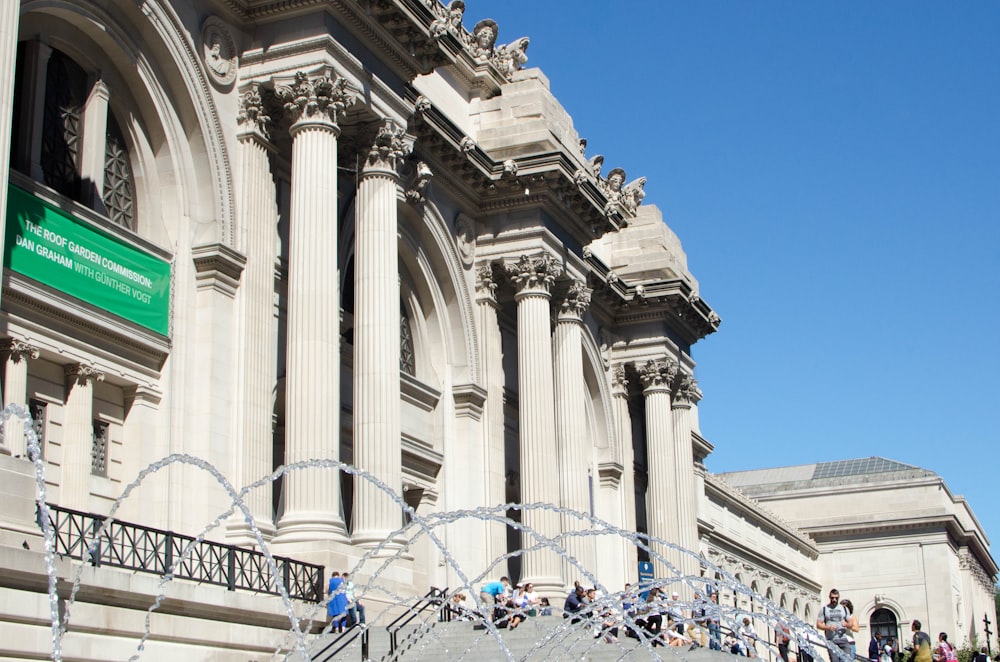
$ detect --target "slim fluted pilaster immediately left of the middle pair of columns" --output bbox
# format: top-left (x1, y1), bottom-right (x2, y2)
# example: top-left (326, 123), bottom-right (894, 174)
top-left (476, 264), bottom-right (507, 572)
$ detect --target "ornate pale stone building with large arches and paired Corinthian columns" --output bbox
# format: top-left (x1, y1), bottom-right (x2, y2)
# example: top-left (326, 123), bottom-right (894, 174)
top-left (0, 0), bottom-right (996, 660)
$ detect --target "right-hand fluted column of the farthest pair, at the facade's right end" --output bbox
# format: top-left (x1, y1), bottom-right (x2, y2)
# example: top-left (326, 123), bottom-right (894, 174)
top-left (672, 375), bottom-right (700, 597)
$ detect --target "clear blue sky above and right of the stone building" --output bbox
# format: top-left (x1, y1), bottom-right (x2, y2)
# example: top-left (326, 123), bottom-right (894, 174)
top-left (474, 0), bottom-right (1000, 554)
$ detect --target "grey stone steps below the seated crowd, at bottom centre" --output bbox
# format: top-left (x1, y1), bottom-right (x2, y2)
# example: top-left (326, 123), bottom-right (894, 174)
top-left (310, 616), bottom-right (745, 662)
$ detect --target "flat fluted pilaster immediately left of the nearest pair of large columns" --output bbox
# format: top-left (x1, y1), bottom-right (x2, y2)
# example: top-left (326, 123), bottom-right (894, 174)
top-left (229, 83), bottom-right (278, 545)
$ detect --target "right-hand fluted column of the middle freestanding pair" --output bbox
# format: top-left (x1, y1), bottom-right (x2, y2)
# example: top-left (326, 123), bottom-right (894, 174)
top-left (554, 281), bottom-right (597, 585)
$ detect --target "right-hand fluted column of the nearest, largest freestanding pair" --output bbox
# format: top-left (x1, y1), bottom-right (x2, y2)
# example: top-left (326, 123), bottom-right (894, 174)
top-left (352, 120), bottom-right (410, 547)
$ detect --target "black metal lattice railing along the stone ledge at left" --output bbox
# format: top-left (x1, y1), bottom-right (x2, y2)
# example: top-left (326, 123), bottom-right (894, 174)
top-left (48, 504), bottom-right (324, 602)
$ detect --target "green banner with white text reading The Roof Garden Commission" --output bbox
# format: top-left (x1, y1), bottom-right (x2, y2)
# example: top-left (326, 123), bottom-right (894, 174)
top-left (3, 185), bottom-right (170, 335)
